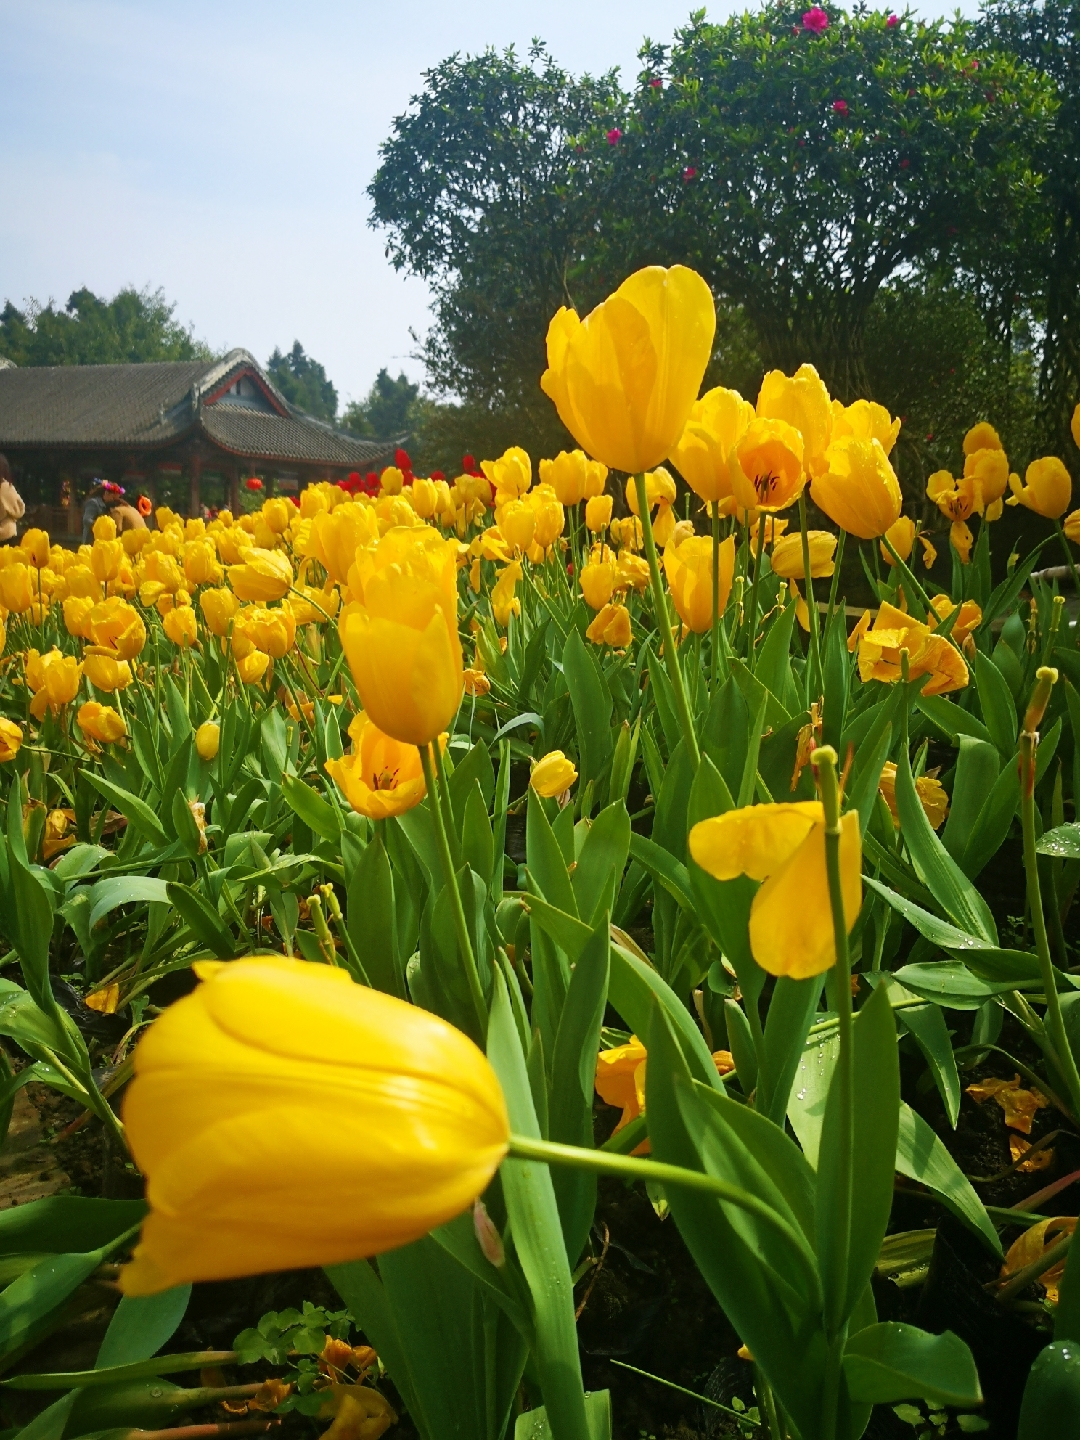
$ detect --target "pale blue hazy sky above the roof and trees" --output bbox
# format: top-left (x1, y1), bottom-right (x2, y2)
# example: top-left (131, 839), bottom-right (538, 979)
top-left (0, 0), bottom-right (973, 405)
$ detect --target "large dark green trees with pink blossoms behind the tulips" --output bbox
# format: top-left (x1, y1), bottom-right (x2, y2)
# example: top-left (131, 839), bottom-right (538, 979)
top-left (369, 0), bottom-right (1080, 475)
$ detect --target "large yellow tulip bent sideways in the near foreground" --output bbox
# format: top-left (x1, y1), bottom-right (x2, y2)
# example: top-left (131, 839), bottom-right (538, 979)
top-left (121, 956), bottom-right (508, 1295)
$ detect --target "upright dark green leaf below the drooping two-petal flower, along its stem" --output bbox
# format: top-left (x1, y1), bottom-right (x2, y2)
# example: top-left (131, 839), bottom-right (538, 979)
top-left (815, 986), bottom-right (900, 1323)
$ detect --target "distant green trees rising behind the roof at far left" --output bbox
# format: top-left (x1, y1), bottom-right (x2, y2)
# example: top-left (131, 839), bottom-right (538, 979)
top-left (0, 287), bottom-right (212, 366)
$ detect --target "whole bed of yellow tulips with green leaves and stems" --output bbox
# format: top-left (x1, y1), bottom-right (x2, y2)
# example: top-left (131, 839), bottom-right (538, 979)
top-left (0, 266), bottom-right (1080, 1440)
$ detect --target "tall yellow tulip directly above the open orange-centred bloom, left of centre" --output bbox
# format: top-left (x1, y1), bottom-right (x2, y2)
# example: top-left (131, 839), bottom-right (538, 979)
top-left (338, 526), bottom-right (464, 744)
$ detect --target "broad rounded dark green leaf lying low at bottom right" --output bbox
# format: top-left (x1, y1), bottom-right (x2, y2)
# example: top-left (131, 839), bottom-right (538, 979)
top-left (844, 1320), bottom-right (982, 1405)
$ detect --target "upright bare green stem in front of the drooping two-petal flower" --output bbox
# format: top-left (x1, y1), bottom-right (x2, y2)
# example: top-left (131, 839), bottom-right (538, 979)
top-left (812, 744), bottom-right (855, 1440)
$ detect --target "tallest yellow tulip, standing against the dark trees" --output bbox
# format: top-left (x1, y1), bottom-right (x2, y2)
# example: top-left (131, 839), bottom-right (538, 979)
top-left (540, 265), bottom-right (716, 475)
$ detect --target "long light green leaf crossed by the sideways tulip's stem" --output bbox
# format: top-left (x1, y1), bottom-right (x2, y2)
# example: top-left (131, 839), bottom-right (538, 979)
top-left (489, 971), bottom-right (588, 1436)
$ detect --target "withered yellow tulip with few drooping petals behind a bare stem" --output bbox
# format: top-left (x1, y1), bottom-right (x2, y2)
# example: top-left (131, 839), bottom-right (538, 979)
top-left (690, 801), bottom-right (863, 979)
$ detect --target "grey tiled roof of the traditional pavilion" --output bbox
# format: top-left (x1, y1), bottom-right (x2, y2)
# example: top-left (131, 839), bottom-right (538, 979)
top-left (0, 350), bottom-right (395, 468)
